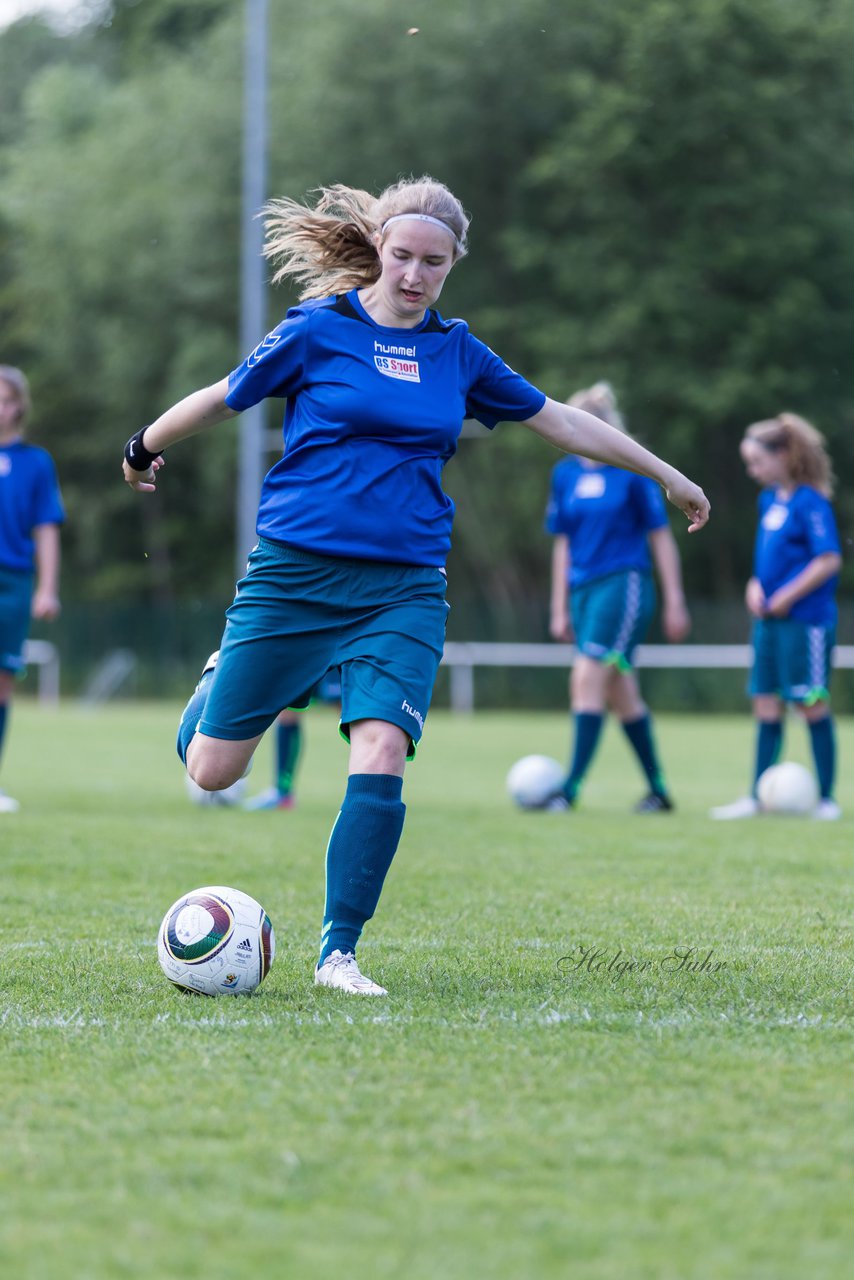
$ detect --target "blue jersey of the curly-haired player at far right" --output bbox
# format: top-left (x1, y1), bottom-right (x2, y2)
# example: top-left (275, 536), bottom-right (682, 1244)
top-left (753, 485), bottom-right (840, 627)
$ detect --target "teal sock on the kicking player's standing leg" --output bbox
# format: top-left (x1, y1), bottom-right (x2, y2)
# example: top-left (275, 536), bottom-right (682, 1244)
top-left (319, 773), bottom-right (406, 964)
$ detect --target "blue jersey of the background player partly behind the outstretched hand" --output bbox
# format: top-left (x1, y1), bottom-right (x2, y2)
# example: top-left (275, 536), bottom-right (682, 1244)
top-left (545, 457), bottom-right (667, 586)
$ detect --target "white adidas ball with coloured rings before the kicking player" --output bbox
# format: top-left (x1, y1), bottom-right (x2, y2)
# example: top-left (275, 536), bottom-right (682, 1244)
top-left (157, 884), bottom-right (275, 996)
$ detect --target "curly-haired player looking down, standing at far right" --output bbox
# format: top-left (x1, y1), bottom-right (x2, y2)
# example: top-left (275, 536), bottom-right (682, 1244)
top-left (712, 413), bottom-right (842, 820)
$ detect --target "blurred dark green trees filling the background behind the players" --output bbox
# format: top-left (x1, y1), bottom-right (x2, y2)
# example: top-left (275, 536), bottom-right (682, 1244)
top-left (0, 0), bottom-right (854, 614)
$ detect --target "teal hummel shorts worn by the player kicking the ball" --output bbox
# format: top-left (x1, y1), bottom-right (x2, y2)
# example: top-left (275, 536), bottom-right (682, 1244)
top-left (198, 538), bottom-right (448, 754)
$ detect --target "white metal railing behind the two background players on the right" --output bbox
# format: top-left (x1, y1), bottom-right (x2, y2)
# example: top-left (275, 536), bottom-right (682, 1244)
top-left (442, 640), bottom-right (854, 712)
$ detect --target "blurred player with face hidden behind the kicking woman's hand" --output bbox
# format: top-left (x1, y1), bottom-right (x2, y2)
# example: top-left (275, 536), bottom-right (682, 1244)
top-left (545, 383), bottom-right (690, 813)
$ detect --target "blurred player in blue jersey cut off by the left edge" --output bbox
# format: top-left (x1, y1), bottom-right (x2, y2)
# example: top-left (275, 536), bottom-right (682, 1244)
top-left (0, 365), bottom-right (65, 814)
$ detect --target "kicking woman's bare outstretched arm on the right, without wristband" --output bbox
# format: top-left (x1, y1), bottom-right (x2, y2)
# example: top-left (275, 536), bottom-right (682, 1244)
top-left (525, 399), bottom-right (709, 534)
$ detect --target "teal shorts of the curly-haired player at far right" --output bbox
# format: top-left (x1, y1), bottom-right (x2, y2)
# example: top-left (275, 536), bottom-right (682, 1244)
top-left (748, 618), bottom-right (836, 707)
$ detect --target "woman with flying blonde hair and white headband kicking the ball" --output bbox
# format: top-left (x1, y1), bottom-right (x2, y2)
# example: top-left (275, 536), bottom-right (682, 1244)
top-left (124, 178), bottom-right (708, 996)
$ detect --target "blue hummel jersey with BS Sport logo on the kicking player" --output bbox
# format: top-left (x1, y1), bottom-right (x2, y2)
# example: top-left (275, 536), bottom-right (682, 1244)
top-left (225, 289), bottom-right (545, 567)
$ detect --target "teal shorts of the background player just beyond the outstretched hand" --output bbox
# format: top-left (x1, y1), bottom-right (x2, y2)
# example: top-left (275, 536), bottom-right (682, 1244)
top-left (570, 568), bottom-right (656, 671)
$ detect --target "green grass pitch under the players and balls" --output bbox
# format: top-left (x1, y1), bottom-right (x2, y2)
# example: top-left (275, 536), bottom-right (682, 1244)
top-left (0, 700), bottom-right (854, 1280)
